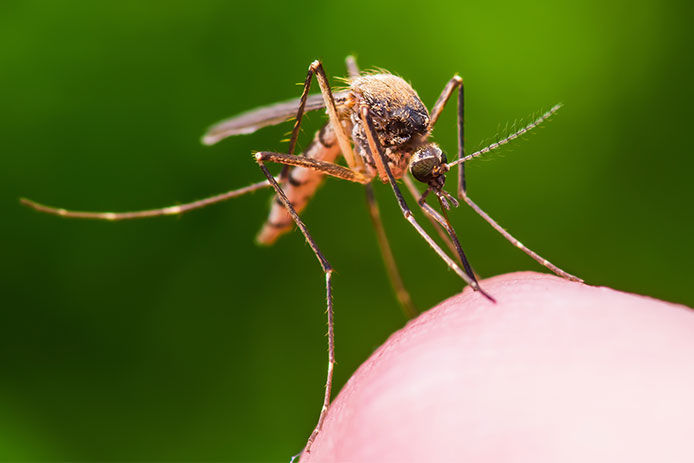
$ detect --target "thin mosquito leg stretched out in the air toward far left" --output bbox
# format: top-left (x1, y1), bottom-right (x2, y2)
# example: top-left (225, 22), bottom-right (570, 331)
top-left (19, 180), bottom-right (270, 221)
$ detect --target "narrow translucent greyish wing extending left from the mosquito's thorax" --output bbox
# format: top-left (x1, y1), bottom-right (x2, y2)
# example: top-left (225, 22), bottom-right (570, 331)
top-left (202, 92), bottom-right (346, 145)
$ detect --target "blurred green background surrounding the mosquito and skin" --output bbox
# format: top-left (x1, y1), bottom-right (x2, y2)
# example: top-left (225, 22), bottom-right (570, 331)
top-left (0, 0), bottom-right (694, 461)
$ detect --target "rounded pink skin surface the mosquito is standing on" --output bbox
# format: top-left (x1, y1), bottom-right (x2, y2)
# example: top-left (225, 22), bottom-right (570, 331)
top-left (301, 272), bottom-right (694, 463)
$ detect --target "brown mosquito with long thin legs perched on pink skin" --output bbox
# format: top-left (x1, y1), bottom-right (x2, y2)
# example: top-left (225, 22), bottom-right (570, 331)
top-left (21, 57), bottom-right (582, 458)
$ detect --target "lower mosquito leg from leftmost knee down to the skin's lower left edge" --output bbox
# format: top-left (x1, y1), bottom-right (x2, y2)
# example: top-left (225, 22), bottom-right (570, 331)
top-left (256, 160), bottom-right (335, 452)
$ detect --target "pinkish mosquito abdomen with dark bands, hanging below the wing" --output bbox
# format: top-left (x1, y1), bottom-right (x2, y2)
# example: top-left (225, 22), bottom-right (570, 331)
top-left (256, 124), bottom-right (340, 245)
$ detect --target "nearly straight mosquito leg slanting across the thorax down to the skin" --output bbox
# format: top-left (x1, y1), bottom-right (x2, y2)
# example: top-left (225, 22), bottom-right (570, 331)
top-left (360, 106), bottom-right (496, 302)
